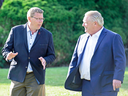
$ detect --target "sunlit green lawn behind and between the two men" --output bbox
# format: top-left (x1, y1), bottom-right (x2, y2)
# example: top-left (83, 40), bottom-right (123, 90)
top-left (0, 67), bottom-right (128, 96)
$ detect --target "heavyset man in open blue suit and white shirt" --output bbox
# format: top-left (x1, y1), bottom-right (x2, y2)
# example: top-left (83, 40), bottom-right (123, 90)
top-left (65, 11), bottom-right (126, 96)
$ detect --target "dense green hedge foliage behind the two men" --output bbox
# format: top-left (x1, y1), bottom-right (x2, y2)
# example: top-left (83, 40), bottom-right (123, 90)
top-left (0, 0), bottom-right (128, 68)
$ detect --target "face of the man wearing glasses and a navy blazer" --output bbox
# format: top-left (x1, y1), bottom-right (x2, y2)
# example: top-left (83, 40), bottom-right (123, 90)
top-left (30, 13), bottom-right (43, 30)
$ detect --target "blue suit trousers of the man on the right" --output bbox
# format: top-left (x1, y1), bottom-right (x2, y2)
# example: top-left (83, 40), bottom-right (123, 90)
top-left (82, 80), bottom-right (117, 96)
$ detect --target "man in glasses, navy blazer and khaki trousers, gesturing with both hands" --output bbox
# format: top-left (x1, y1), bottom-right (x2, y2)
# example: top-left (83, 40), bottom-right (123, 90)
top-left (2, 7), bottom-right (55, 96)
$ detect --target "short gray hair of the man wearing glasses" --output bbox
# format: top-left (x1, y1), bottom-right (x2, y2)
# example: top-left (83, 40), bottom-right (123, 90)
top-left (27, 7), bottom-right (44, 17)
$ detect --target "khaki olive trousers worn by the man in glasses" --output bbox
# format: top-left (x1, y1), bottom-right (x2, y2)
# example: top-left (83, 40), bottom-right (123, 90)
top-left (10, 73), bottom-right (45, 96)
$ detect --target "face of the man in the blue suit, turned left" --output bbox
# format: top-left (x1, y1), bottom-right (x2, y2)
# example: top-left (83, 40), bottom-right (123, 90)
top-left (82, 16), bottom-right (94, 34)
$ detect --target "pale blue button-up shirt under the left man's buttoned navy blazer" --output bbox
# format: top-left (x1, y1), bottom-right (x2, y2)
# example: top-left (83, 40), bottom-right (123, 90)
top-left (27, 26), bottom-right (38, 72)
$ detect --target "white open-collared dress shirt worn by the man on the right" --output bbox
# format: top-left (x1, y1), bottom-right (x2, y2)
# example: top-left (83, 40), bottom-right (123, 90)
top-left (79, 27), bottom-right (103, 80)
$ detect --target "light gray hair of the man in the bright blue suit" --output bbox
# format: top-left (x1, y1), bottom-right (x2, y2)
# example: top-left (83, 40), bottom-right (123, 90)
top-left (85, 11), bottom-right (104, 26)
